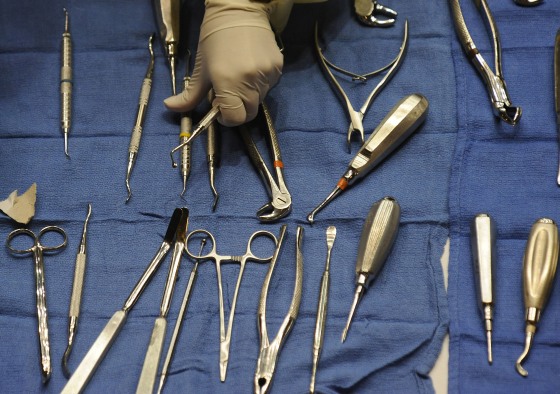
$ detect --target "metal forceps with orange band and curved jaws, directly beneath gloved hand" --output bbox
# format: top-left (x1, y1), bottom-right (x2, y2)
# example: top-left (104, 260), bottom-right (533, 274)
top-left (239, 102), bottom-right (292, 222)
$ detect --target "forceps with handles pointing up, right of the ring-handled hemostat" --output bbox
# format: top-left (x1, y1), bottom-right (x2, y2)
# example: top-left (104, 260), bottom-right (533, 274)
top-left (254, 225), bottom-right (303, 394)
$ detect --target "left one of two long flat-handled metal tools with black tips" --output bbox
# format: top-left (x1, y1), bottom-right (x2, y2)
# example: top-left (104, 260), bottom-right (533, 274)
top-left (61, 208), bottom-right (189, 394)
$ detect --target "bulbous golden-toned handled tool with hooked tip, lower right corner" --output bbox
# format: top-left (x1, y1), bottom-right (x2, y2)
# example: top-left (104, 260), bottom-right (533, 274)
top-left (515, 218), bottom-right (558, 376)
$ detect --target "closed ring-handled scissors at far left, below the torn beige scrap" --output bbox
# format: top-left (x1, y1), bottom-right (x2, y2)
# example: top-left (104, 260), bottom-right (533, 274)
top-left (6, 226), bottom-right (68, 384)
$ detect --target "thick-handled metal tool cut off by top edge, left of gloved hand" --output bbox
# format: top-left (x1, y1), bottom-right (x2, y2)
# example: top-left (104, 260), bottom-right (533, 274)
top-left (153, 0), bottom-right (181, 95)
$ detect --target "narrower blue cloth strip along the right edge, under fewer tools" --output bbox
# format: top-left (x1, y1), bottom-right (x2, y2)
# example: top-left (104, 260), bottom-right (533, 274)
top-left (448, 0), bottom-right (560, 393)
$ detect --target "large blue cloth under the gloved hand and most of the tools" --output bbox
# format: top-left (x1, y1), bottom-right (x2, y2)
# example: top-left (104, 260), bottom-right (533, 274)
top-left (0, 0), bottom-right (446, 393)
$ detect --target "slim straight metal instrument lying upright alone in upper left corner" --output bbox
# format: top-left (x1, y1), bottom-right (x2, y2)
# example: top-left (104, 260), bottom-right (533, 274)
top-left (60, 8), bottom-right (73, 158)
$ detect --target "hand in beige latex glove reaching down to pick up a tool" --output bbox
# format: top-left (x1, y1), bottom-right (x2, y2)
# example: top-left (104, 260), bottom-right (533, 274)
top-left (164, 0), bottom-right (284, 126)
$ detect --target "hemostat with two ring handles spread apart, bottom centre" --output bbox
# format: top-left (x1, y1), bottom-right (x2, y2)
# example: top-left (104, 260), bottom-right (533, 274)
top-left (185, 230), bottom-right (278, 382)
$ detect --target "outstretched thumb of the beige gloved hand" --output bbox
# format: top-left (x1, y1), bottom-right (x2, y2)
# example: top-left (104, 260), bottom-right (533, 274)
top-left (163, 51), bottom-right (211, 112)
